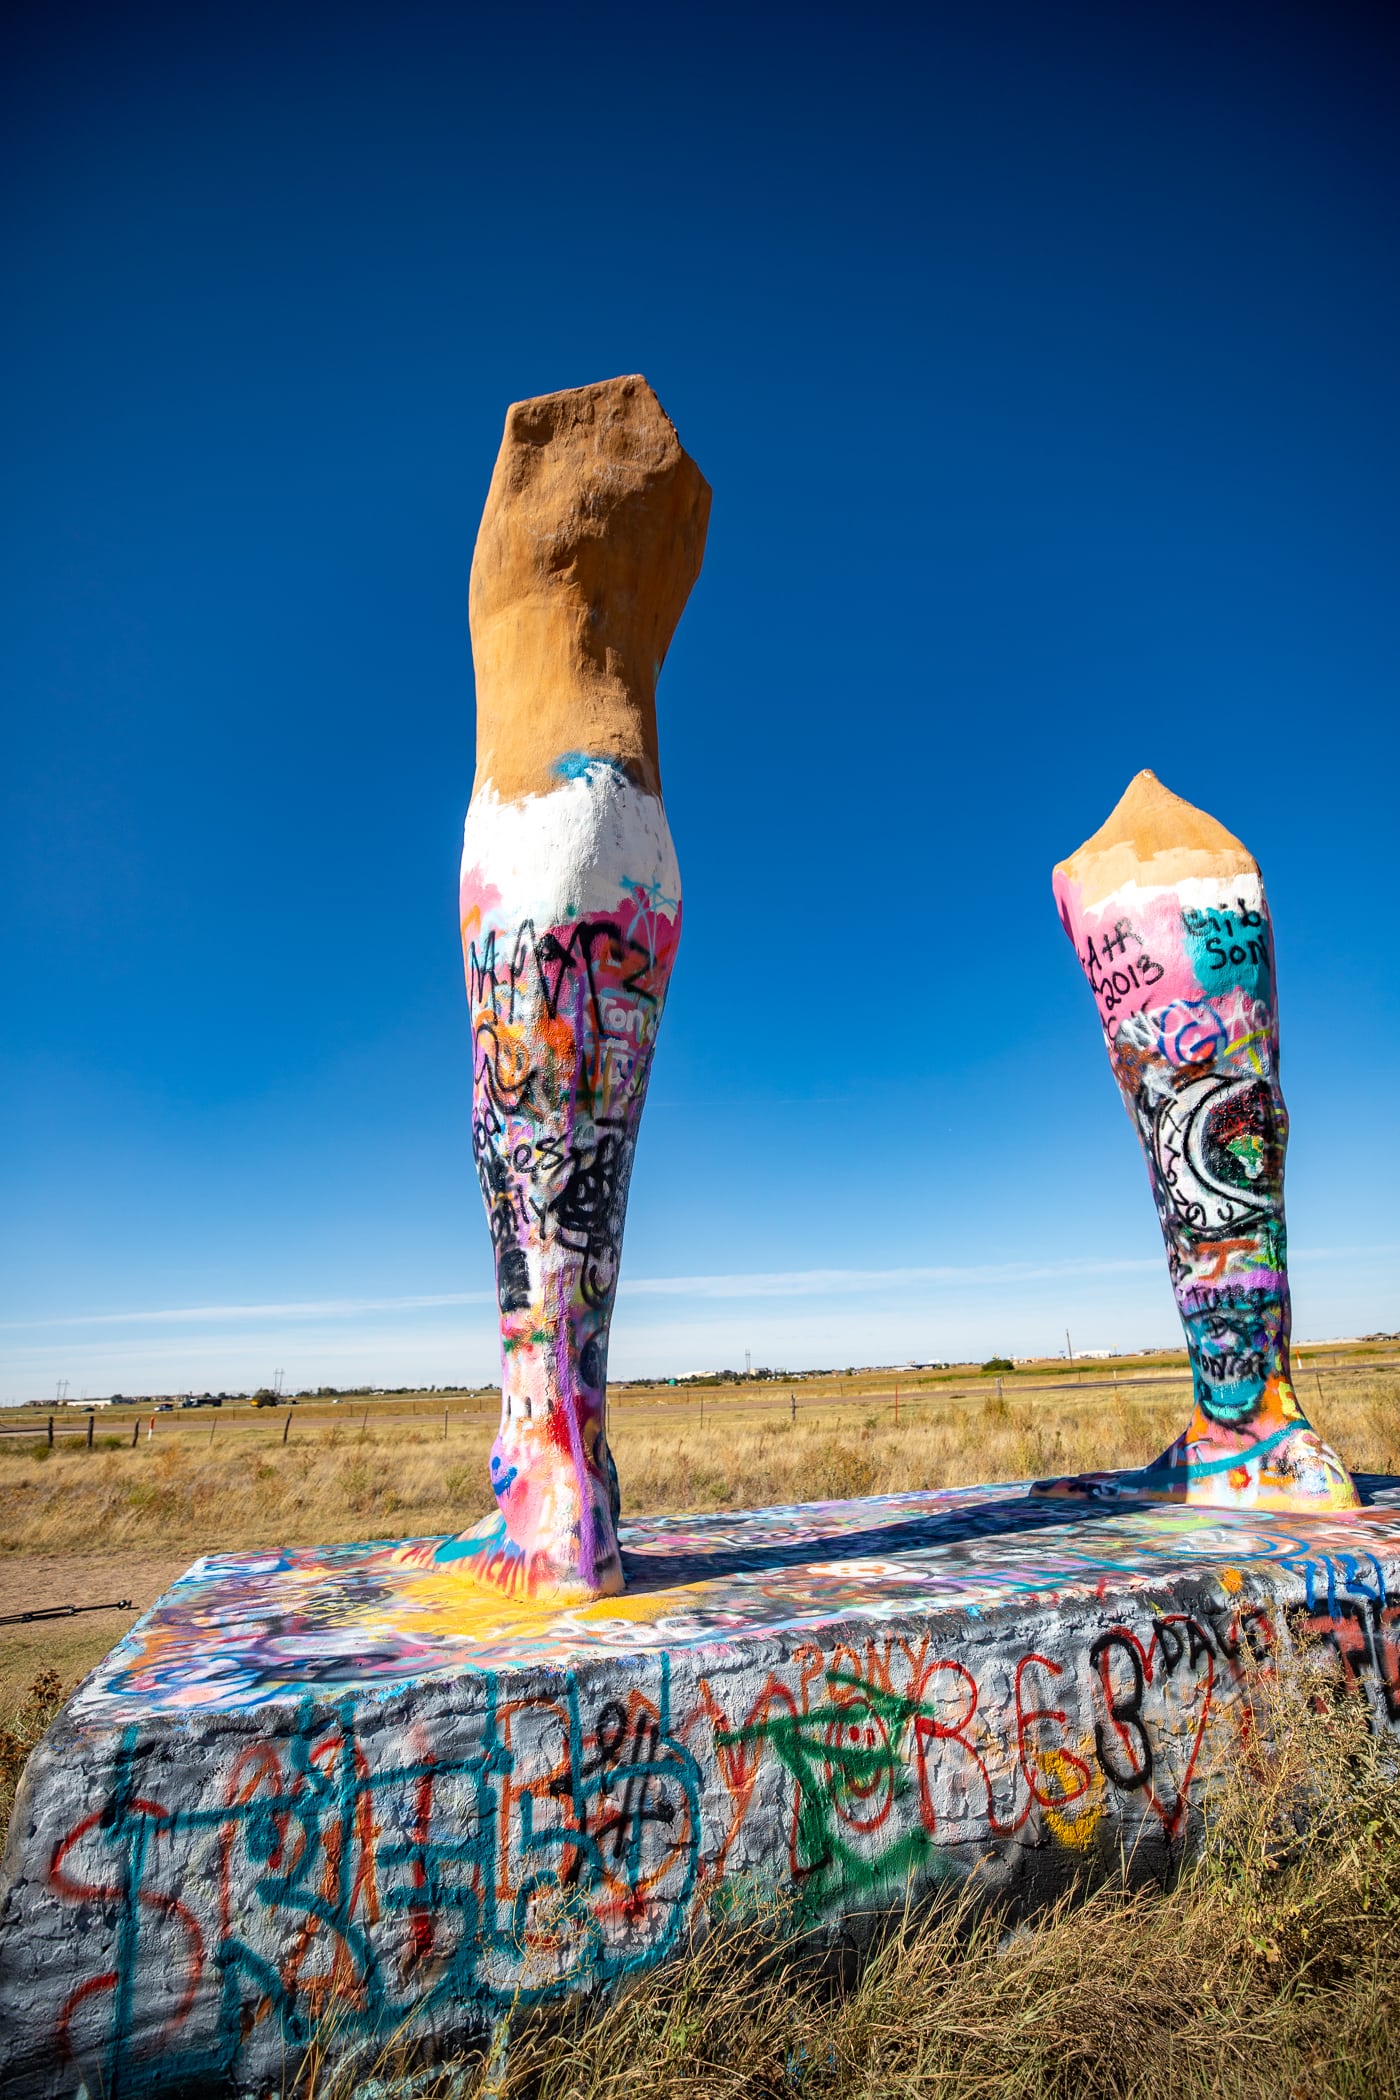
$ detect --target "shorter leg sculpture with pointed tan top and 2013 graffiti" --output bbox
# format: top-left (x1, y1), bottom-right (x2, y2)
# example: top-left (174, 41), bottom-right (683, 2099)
top-left (1054, 773), bottom-right (1356, 1512)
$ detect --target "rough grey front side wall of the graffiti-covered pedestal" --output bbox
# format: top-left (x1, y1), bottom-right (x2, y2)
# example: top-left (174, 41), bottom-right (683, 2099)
top-left (0, 1554), bottom-right (1400, 2100)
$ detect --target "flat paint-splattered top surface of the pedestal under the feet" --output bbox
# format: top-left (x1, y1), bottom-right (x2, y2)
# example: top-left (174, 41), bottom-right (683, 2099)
top-left (69, 1481), bottom-right (1400, 1726)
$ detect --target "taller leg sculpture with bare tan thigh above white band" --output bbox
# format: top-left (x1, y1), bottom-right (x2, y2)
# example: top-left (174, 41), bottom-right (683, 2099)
top-left (441, 378), bottom-right (709, 1602)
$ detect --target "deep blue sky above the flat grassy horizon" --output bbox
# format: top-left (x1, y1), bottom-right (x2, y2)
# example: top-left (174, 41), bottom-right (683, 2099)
top-left (0, 0), bottom-right (1400, 1399)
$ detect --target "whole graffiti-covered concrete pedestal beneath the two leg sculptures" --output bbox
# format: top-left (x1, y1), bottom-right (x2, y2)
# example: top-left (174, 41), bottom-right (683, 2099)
top-left (0, 1483), bottom-right (1400, 2100)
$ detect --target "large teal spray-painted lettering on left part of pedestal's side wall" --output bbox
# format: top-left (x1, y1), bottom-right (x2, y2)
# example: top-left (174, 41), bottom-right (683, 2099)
top-left (48, 1659), bottom-right (699, 2100)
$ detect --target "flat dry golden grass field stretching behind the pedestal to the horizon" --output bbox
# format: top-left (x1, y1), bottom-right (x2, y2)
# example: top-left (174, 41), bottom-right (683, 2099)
top-left (0, 1344), bottom-right (1400, 1720)
